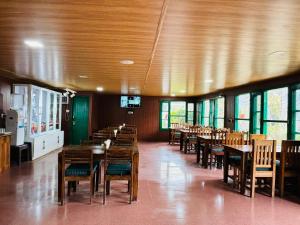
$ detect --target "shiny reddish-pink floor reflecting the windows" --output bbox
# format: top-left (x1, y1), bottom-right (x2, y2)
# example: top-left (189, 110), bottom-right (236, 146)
top-left (0, 143), bottom-right (300, 225)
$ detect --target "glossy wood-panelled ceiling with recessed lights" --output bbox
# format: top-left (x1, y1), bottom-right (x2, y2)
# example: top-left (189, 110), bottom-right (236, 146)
top-left (0, 0), bottom-right (300, 96)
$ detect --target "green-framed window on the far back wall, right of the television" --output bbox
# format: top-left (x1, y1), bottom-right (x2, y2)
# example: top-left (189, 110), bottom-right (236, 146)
top-left (160, 101), bottom-right (188, 130)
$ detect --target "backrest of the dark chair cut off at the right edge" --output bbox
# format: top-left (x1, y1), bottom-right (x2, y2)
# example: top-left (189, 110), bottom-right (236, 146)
top-left (280, 141), bottom-right (300, 170)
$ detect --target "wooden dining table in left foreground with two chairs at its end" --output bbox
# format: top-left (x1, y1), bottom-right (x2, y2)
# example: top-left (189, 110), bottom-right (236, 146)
top-left (57, 145), bottom-right (139, 202)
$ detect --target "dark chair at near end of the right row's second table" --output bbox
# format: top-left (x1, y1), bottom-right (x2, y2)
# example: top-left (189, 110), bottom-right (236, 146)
top-left (208, 130), bottom-right (227, 168)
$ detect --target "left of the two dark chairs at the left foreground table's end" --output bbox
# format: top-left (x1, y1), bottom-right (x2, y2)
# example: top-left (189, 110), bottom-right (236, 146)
top-left (61, 149), bottom-right (98, 205)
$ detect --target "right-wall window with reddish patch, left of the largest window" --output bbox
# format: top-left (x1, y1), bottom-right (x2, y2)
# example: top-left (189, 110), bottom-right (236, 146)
top-left (235, 93), bottom-right (250, 131)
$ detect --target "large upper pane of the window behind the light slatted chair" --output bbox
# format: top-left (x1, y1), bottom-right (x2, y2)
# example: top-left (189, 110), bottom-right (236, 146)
top-left (264, 88), bottom-right (288, 120)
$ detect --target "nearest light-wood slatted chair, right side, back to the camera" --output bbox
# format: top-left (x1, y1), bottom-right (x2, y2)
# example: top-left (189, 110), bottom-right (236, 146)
top-left (246, 140), bottom-right (276, 198)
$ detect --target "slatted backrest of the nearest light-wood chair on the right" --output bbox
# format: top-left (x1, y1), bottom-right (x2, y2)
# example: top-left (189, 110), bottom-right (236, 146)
top-left (252, 140), bottom-right (276, 170)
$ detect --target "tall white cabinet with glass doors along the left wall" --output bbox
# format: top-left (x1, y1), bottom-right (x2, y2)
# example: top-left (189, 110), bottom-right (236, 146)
top-left (13, 84), bottom-right (64, 159)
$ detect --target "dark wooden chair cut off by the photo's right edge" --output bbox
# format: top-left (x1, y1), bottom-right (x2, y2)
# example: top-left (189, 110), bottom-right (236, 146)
top-left (277, 141), bottom-right (300, 197)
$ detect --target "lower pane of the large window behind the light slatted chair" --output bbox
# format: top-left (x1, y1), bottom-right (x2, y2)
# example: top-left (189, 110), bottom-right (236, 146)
top-left (265, 122), bottom-right (287, 144)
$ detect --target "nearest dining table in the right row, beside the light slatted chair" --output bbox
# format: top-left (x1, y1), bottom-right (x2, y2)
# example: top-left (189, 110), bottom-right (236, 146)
top-left (223, 145), bottom-right (281, 194)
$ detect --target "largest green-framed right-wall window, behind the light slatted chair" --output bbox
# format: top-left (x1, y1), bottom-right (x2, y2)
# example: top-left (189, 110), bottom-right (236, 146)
top-left (263, 87), bottom-right (288, 142)
